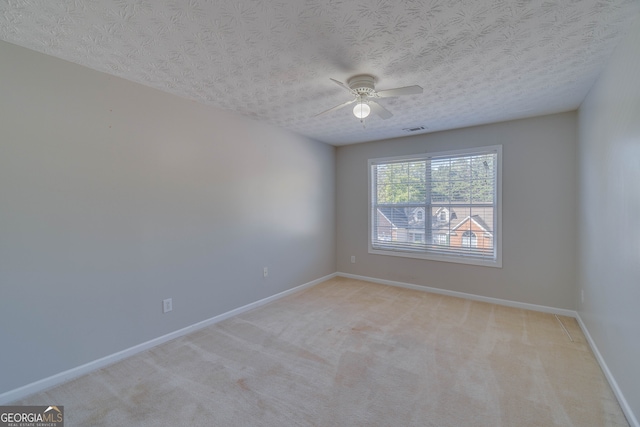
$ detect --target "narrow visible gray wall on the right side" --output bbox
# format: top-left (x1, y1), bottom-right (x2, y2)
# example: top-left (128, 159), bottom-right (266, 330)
top-left (577, 20), bottom-right (640, 424)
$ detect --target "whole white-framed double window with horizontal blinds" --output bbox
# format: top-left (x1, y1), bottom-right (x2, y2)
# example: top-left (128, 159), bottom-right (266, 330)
top-left (369, 146), bottom-right (502, 267)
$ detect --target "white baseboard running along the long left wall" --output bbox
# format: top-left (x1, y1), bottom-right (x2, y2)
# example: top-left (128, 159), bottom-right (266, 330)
top-left (0, 273), bottom-right (336, 405)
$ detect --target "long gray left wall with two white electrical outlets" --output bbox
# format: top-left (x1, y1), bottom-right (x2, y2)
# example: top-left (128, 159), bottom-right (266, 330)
top-left (0, 42), bottom-right (336, 393)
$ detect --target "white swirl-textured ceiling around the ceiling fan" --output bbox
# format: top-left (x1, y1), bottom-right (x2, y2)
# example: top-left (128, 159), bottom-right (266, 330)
top-left (0, 0), bottom-right (640, 145)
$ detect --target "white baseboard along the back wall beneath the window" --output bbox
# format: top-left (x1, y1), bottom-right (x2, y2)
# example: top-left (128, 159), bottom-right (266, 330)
top-left (336, 272), bottom-right (578, 317)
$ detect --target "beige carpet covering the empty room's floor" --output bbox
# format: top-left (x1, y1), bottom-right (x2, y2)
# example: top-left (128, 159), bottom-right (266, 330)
top-left (12, 278), bottom-right (628, 427)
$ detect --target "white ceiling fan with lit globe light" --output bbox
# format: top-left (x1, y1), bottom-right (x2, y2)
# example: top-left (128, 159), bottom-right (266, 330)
top-left (314, 74), bottom-right (422, 121)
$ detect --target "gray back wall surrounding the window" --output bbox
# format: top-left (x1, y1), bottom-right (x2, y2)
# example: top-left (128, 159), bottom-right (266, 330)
top-left (336, 112), bottom-right (578, 309)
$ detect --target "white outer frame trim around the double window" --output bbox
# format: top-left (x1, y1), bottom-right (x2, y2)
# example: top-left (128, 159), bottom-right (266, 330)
top-left (367, 145), bottom-right (502, 268)
